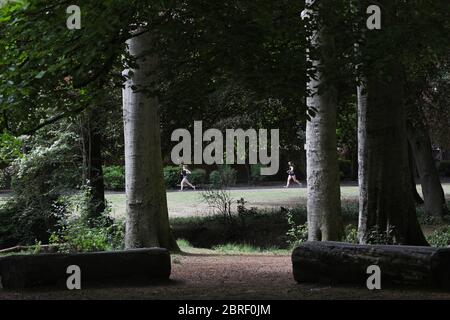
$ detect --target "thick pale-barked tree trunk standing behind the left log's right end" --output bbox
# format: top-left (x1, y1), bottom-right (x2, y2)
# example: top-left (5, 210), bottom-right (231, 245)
top-left (123, 32), bottom-right (178, 250)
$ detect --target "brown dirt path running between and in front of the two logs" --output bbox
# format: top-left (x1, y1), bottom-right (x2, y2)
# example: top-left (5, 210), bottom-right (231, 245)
top-left (0, 255), bottom-right (450, 300)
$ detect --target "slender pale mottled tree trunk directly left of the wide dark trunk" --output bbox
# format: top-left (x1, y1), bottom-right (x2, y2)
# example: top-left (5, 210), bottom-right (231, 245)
top-left (306, 0), bottom-right (343, 241)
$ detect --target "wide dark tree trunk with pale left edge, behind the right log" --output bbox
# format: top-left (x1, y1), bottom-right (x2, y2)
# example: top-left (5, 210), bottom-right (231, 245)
top-left (358, 0), bottom-right (427, 245)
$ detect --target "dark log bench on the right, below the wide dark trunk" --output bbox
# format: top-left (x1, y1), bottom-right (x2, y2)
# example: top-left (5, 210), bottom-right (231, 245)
top-left (292, 241), bottom-right (450, 289)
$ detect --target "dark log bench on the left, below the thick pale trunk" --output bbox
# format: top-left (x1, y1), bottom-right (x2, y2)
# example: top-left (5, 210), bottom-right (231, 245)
top-left (0, 248), bottom-right (171, 289)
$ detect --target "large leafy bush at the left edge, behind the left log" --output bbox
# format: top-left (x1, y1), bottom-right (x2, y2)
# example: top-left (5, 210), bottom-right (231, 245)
top-left (0, 133), bottom-right (81, 247)
